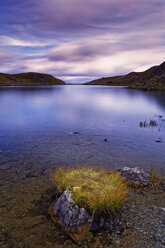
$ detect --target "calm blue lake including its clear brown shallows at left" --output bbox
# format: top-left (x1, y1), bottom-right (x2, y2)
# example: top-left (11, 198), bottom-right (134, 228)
top-left (0, 85), bottom-right (165, 248)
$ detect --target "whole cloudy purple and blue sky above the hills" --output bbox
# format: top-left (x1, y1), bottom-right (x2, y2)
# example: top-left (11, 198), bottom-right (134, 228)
top-left (0, 0), bottom-right (165, 83)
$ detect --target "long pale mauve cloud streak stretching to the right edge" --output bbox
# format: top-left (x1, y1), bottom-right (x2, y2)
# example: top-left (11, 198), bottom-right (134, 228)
top-left (48, 32), bottom-right (165, 62)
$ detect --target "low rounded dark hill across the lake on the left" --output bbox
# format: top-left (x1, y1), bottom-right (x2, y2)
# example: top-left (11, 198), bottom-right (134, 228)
top-left (0, 72), bottom-right (65, 86)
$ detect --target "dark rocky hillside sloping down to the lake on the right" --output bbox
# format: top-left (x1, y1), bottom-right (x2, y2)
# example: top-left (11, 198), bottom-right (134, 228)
top-left (86, 62), bottom-right (165, 90)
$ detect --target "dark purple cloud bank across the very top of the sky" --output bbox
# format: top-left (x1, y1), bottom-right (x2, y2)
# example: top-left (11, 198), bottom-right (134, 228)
top-left (0, 0), bottom-right (165, 37)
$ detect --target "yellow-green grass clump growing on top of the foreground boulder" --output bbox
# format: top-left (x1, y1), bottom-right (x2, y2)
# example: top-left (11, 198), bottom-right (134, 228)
top-left (53, 166), bottom-right (127, 214)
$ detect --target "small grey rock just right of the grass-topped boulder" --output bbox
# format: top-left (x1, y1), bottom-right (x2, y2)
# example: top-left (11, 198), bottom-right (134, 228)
top-left (118, 167), bottom-right (150, 187)
